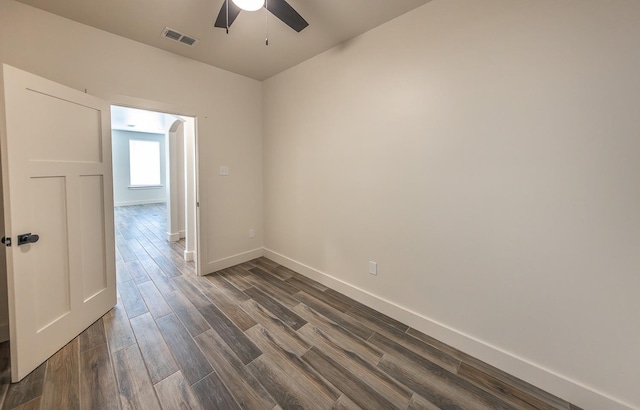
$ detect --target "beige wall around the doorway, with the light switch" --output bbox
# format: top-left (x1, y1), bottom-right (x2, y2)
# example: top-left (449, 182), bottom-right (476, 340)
top-left (0, 0), bottom-right (262, 273)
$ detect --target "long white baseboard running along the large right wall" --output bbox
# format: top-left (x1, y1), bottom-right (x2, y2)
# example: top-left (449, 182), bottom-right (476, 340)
top-left (263, 248), bottom-right (637, 410)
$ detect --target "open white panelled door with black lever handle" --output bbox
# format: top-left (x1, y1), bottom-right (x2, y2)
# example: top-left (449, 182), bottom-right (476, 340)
top-left (0, 65), bottom-right (116, 382)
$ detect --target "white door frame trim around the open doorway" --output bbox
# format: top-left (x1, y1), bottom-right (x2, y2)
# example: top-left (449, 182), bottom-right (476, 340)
top-left (102, 92), bottom-right (202, 276)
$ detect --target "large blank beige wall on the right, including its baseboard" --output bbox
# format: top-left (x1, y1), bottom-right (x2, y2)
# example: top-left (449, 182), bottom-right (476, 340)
top-left (263, 0), bottom-right (640, 409)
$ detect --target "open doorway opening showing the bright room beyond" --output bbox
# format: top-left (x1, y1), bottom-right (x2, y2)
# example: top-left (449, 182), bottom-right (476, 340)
top-left (111, 105), bottom-right (198, 275)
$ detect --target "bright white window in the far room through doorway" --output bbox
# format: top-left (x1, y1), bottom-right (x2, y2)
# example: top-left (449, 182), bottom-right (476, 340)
top-left (129, 139), bottom-right (160, 187)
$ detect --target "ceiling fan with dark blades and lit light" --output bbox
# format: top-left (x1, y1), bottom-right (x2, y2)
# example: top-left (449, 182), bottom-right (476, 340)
top-left (215, 0), bottom-right (309, 33)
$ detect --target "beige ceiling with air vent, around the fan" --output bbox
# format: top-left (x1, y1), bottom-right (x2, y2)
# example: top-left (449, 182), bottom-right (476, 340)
top-left (19, 0), bottom-right (429, 80)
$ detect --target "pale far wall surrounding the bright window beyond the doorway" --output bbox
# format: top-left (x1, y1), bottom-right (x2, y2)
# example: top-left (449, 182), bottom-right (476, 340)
top-left (111, 130), bottom-right (167, 206)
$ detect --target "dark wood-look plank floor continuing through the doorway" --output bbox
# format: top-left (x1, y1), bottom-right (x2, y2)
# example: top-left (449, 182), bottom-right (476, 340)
top-left (0, 205), bottom-right (576, 410)
